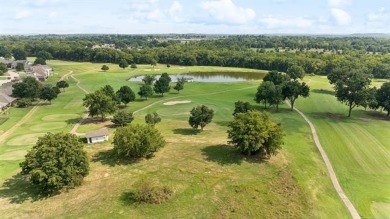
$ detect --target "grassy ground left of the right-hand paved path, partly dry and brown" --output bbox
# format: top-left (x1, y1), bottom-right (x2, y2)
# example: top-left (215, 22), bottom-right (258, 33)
top-left (0, 61), bottom-right (356, 218)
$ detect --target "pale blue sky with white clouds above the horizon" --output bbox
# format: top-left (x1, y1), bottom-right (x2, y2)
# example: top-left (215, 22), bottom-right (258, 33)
top-left (0, 0), bottom-right (390, 34)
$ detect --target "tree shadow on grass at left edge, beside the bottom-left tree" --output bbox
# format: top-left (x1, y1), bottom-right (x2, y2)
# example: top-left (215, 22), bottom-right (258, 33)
top-left (0, 174), bottom-right (48, 204)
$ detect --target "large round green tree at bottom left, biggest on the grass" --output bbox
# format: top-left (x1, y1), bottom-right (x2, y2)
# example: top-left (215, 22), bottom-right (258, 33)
top-left (20, 133), bottom-right (89, 194)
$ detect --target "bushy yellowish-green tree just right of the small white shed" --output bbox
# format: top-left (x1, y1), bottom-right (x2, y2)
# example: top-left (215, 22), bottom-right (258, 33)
top-left (113, 124), bottom-right (165, 158)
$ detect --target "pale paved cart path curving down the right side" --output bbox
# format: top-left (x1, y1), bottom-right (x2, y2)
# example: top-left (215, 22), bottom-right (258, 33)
top-left (287, 103), bottom-right (360, 219)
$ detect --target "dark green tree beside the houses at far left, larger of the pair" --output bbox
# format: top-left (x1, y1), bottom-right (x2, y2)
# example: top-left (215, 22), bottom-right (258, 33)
top-left (12, 77), bottom-right (42, 99)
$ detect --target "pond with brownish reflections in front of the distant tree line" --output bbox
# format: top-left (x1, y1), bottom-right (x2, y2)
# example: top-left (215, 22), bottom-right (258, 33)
top-left (129, 72), bottom-right (265, 82)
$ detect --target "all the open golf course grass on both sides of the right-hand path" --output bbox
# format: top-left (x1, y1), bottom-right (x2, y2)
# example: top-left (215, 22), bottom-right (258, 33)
top-left (0, 61), bottom-right (390, 218)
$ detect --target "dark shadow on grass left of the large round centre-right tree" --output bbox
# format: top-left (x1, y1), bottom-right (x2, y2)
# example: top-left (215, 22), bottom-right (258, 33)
top-left (202, 145), bottom-right (242, 166)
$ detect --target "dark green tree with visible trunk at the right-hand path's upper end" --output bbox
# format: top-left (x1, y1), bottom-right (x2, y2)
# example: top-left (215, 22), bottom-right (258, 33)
top-left (282, 80), bottom-right (310, 111)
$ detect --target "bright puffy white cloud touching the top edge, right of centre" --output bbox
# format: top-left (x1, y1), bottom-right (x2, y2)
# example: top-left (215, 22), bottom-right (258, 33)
top-left (201, 0), bottom-right (256, 24)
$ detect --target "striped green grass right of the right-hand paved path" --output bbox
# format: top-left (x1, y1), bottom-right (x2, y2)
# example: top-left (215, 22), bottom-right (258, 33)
top-left (297, 77), bottom-right (390, 218)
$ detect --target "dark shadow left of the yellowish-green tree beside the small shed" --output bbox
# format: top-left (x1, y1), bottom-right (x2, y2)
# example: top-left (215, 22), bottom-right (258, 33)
top-left (91, 149), bottom-right (140, 167)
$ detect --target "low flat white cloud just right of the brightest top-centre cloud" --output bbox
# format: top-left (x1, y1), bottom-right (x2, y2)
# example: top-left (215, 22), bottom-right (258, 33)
top-left (259, 15), bottom-right (313, 29)
